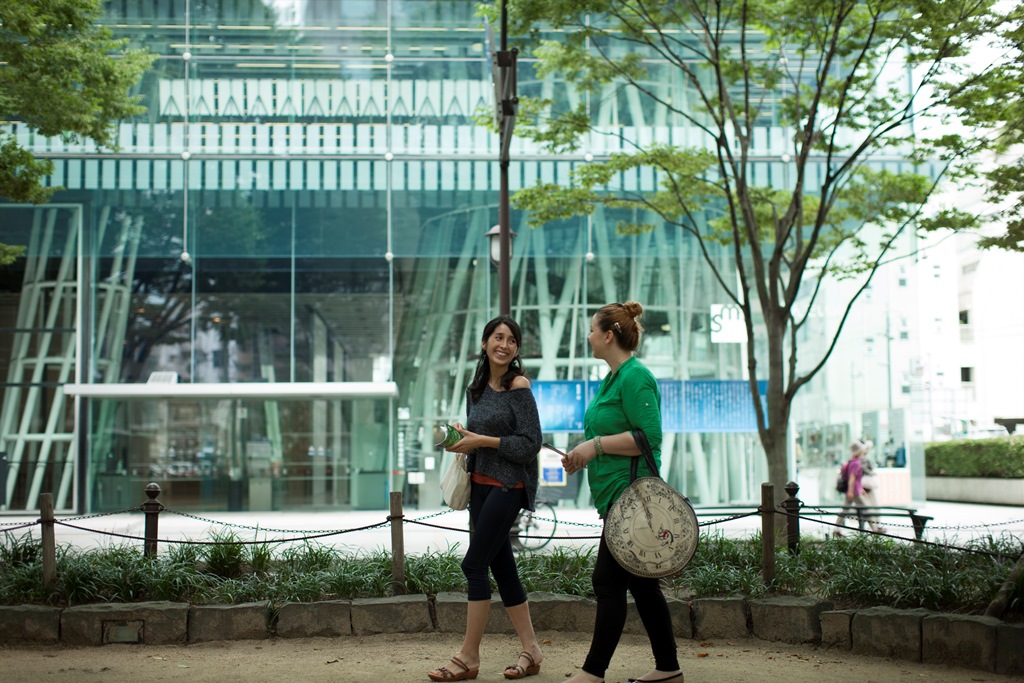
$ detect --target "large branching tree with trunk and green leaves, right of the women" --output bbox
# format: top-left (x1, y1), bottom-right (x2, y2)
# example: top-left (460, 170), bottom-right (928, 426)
top-left (484, 0), bottom-right (1022, 485)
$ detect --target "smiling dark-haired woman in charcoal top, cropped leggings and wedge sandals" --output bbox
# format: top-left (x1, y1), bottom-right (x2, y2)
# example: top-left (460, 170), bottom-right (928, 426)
top-left (427, 315), bottom-right (544, 681)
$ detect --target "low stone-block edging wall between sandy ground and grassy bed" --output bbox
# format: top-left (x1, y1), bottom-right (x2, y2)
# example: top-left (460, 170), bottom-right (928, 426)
top-left (0, 593), bottom-right (1024, 675)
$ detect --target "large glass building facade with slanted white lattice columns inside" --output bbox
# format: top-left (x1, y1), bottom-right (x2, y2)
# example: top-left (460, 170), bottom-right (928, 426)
top-left (0, 0), bottom-right (784, 511)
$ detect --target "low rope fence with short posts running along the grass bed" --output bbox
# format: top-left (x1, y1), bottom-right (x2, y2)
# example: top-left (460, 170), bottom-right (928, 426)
top-left (6, 481), bottom-right (1024, 594)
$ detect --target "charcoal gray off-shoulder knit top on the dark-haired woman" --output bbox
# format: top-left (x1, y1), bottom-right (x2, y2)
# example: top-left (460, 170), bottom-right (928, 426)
top-left (466, 386), bottom-right (543, 510)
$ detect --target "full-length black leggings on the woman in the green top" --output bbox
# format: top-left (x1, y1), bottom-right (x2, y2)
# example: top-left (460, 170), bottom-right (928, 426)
top-left (583, 535), bottom-right (679, 678)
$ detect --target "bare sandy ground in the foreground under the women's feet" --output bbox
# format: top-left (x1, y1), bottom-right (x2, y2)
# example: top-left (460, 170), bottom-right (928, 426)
top-left (0, 632), bottom-right (1024, 683)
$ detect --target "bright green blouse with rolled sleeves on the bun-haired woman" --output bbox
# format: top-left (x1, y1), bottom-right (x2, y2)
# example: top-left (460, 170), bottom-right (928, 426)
top-left (583, 357), bottom-right (662, 518)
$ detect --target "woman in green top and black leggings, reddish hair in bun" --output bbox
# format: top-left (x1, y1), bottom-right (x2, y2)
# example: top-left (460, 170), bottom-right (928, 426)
top-left (562, 301), bottom-right (683, 683)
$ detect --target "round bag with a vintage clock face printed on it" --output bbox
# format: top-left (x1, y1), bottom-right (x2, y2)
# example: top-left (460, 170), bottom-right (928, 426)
top-left (604, 477), bottom-right (698, 579)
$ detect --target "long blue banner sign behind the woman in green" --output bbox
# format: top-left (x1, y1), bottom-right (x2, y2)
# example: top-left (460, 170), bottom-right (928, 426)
top-left (532, 380), bottom-right (767, 434)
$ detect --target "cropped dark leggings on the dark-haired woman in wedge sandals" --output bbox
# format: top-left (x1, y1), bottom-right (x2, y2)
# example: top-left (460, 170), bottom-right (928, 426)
top-left (462, 483), bottom-right (526, 607)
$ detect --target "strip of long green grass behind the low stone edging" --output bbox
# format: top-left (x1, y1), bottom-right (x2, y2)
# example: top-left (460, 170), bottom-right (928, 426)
top-left (0, 531), bottom-right (1024, 621)
